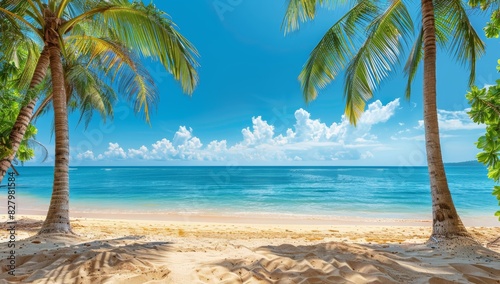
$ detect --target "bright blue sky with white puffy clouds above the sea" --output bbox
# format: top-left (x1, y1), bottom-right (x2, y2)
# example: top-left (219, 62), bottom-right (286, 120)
top-left (29, 0), bottom-right (499, 166)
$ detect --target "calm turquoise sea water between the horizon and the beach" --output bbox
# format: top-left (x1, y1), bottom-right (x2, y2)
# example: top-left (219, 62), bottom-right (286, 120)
top-left (5, 166), bottom-right (498, 218)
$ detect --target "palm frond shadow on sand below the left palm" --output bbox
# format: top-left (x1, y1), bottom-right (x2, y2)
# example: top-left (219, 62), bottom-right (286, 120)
top-left (0, 220), bottom-right (171, 283)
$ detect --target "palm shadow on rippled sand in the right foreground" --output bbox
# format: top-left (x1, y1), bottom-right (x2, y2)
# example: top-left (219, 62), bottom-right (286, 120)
top-left (195, 242), bottom-right (500, 284)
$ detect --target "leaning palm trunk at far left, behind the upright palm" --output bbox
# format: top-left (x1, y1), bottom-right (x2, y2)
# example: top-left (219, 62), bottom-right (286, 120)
top-left (0, 47), bottom-right (49, 183)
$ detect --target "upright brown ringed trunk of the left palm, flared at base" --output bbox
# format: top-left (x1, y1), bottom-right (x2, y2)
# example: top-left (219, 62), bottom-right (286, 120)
top-left (39, 38), bottom-right (73, 234)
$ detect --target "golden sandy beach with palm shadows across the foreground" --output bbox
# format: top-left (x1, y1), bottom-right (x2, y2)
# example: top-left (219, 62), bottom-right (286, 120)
top-left (0, 215), bottom-right (500, 284)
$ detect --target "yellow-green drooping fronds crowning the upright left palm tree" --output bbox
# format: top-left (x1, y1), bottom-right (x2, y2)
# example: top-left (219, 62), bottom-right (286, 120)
top-left (0, 0), bottom-right (198, 121)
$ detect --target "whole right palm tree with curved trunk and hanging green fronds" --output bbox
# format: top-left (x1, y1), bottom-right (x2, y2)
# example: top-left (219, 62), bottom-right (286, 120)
top-left (283, 0), bottom-right (484, 242)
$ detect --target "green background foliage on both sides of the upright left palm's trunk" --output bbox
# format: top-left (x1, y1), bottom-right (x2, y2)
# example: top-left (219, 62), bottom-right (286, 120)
top-left (0, 15), bottom-right (113, 175)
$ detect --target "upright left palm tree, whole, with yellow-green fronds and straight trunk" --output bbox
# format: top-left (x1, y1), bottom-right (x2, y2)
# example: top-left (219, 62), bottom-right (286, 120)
top-left (0, 0), bottom-right (198, 233)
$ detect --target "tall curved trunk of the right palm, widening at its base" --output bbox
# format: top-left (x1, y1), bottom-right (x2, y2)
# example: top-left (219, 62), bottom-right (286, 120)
top-left (421, 0), bottom-right (472, 242)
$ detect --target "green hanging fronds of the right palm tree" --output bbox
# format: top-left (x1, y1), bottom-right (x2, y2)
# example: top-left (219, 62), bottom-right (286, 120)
top-left (283, 0), bottom-right (485, 124)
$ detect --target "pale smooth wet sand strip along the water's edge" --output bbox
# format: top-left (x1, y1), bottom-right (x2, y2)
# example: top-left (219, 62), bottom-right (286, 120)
top-left (0, 192), bottom-right (500, 227)
